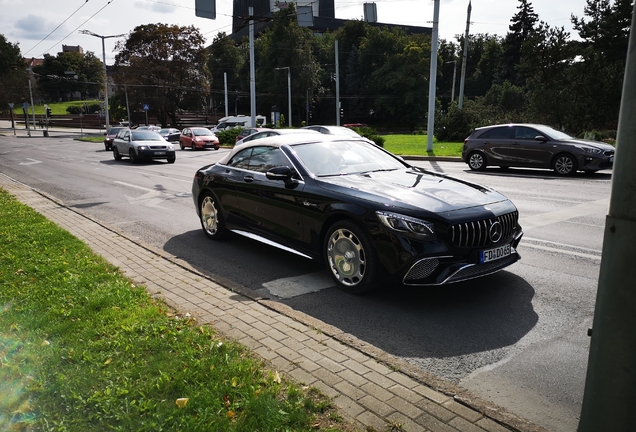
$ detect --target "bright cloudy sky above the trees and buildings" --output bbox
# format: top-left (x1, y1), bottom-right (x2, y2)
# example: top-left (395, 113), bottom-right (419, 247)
top-left (0, 0), bottom-right (586, 65)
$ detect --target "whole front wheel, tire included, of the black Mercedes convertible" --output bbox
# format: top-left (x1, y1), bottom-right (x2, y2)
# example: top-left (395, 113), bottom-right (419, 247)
top-left (324, 220), bottom-right (379, 294)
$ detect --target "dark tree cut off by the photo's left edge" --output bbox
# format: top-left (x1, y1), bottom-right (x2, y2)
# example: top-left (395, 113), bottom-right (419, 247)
top-left (0, 34), bottom-right (28, 110)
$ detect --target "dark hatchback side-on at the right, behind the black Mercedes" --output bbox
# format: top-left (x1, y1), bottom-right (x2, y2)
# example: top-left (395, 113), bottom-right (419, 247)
top-left (462, 123), bottom-right (616, 176)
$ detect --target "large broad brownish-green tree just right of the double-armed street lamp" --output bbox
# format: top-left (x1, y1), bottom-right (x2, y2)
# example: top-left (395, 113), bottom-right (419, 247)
top-left (114, 24), bottom-right (210, 126)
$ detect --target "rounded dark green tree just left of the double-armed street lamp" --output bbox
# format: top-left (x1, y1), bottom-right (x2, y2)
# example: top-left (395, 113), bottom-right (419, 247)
top-left (33, 51), bottom-right (104, 101)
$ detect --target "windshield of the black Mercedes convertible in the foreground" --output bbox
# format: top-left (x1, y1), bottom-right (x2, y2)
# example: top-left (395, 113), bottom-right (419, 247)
top-left (293, 141), bottom-right (405, 177)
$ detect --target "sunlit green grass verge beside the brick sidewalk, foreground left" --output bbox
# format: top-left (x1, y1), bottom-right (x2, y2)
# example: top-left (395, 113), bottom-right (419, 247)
top-left (0, 189), bottom-right (349, 431)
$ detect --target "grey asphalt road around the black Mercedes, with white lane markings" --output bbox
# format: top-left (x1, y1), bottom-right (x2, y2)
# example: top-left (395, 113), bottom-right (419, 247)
top-left (0, 135), bottom-right (611, 431)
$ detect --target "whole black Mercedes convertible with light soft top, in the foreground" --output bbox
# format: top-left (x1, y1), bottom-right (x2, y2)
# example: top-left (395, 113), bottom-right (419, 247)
top-left (192, 134), bottom-right (523, 293)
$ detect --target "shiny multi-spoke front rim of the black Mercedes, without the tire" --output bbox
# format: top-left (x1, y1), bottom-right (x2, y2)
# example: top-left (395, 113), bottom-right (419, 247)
top-left (327, 228), bottom-right (367, 287)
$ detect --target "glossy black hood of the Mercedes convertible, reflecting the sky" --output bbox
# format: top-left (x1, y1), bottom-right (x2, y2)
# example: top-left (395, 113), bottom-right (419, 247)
top-left (317, 168), bottom-right (507, 213)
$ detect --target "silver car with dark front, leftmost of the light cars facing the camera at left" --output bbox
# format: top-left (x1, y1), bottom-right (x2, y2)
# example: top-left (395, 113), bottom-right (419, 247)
top-left (113, 129), bottom-right (176, 163)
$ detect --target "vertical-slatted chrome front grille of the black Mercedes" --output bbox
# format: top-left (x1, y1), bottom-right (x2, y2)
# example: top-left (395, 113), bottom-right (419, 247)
top-left (450, 211), bottom-right (519, 247)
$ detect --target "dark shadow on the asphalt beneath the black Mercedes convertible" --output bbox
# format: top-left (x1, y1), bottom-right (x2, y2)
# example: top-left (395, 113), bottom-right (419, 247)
top-left (164, 230), bottom-right (538, 358)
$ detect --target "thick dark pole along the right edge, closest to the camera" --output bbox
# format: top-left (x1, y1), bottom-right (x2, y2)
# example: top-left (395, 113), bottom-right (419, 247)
top-left (578, 5), bottom-right (636, 432)
